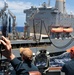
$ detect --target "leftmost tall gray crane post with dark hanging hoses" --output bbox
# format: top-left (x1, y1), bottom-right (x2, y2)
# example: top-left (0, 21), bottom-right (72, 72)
top-left (0, 1), bottom-right (8, 37)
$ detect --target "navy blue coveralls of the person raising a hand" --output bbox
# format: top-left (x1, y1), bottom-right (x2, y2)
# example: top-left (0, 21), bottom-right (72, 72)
top-left (10, 58), bottom-right (38, 75)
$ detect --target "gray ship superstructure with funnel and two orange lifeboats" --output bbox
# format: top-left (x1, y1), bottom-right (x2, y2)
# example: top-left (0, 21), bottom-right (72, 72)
top-left (24, 0), bottom-right (74, 38)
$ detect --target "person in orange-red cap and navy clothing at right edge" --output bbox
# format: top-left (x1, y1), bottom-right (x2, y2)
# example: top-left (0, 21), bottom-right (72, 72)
top-left (61, 46), bottom-right (74, 75)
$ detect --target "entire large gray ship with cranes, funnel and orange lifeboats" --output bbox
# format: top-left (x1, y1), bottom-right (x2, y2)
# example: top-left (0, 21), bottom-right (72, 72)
top-left (0, 0), bottom-right (74, 75)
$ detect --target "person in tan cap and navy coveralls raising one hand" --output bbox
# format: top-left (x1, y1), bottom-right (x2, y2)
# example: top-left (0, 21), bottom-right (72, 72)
top-left (0, 36), bottom-right (41, 75)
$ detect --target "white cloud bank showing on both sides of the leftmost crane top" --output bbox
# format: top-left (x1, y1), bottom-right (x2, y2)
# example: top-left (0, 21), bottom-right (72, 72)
top-left (0, 0), bottom-right (33, 13)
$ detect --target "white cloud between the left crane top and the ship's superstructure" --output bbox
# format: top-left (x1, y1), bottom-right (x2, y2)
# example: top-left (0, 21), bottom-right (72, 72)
top-left (7, 1), bottom-right (32, 13)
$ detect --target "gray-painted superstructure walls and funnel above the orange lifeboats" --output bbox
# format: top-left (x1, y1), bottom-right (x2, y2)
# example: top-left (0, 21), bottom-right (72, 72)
top-left (24, 0), bottom-right (74, 36)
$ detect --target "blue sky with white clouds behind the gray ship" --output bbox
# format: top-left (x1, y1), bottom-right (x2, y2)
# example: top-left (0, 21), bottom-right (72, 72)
top-left (0, 0), bottom-right (74, 26)
